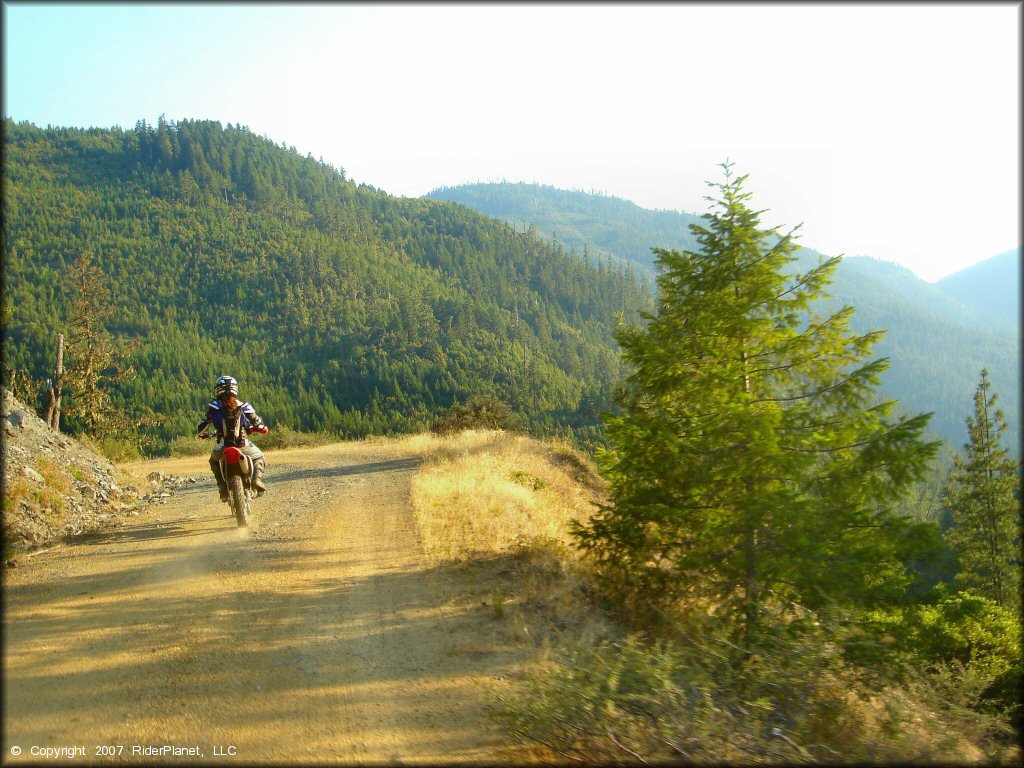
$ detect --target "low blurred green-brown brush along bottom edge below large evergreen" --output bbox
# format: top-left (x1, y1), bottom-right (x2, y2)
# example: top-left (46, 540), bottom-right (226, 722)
top-left (493, 616), bottom-right (1003, 765)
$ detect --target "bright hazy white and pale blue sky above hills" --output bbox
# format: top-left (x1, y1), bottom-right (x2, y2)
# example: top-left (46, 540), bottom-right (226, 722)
top-left (3, 2), bottom-right (1021, 281)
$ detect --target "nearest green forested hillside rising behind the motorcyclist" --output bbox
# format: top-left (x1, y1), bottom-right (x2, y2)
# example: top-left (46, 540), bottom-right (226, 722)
top-left (3, 120), bottom-right (651, 450)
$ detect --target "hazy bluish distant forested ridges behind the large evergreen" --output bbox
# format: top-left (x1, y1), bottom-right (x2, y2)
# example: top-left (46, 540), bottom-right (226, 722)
top-left (427, 183), bottom-right (1020, 451)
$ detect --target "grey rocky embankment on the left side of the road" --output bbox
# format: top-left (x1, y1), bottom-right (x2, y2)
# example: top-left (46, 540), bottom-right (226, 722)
top-left (0, 390), bottom-right (196, 557)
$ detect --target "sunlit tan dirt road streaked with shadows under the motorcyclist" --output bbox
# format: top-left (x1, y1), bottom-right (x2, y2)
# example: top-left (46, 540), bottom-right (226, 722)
top-left (3, 446), bottom-right (536, 764)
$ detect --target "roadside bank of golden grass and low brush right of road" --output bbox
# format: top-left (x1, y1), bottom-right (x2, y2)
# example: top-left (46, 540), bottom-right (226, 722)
top-left (387, 431), bottom-right (1020, 764)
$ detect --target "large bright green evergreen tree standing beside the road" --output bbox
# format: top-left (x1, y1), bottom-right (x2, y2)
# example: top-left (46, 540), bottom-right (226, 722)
top-left (577, 164), bottom-right (938, 641)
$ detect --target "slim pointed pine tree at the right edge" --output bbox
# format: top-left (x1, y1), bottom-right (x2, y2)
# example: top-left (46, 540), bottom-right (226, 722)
top-left (943, 370), bottom-right (1021, 608)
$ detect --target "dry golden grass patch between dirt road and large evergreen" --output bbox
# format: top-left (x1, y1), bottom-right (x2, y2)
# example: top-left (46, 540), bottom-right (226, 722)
top-left (395, 430), bottom-right (608, 663)
